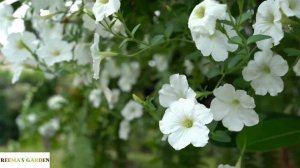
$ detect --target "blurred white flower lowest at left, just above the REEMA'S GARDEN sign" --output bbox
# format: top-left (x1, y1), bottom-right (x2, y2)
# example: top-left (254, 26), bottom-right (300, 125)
top-left (38, 119), bottom-right (60, 137)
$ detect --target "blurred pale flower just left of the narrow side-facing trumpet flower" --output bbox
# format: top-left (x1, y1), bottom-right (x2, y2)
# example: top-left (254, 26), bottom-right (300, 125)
top-left (74, 42), bottom-right (92, 65)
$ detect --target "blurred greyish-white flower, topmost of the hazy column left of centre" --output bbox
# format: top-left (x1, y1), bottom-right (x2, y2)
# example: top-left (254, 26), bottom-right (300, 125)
top-left (118, 62), bottom-right (140, 92)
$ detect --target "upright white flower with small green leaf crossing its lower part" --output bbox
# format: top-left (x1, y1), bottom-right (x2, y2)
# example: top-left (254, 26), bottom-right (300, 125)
top-left (253, 0), bottom-right (284, 50)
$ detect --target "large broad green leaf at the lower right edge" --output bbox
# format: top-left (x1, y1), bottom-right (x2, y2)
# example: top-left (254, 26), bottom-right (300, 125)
top-left (236, 118), bottom-right (300, 151)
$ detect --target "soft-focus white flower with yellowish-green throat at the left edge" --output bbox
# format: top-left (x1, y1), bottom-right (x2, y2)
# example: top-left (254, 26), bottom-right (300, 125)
top-left (1, 32), bottom-right (37, 64)
